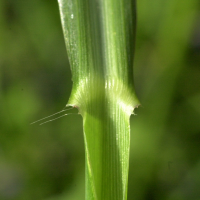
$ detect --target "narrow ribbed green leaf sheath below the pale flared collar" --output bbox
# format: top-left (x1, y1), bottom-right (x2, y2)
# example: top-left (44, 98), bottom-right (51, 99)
top-left (84, 103), bottom-right (130, 200)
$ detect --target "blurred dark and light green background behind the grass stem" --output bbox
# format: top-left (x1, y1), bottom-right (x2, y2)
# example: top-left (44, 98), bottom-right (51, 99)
top-left (0, 0), bottom-right (200, 200)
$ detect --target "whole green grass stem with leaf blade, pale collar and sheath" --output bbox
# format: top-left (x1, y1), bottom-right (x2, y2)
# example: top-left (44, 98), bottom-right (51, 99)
top-left (58, 0), bottom-right (139, 200)
